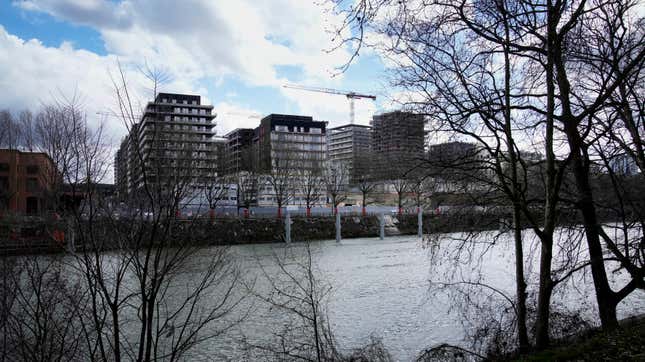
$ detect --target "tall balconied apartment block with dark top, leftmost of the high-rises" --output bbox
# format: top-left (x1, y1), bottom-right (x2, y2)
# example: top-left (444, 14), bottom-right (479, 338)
top-left (115, 93), bottom-right (218, 198)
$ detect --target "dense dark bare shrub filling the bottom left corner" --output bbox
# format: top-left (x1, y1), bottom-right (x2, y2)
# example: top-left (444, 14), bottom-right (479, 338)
top-left (0, 256), bottom-right (87, 361)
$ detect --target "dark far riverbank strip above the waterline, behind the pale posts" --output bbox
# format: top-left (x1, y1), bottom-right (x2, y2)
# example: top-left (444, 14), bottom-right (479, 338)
top-left (0, 213), bottom-right (507, 255)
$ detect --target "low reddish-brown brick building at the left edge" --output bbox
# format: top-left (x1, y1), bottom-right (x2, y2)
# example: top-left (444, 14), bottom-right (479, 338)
top-left (0, 149), bottom-right (60, 215)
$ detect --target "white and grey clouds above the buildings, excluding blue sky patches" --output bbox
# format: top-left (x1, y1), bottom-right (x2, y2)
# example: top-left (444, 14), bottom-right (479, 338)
top-left (0, 0), bottom-right (375, 132)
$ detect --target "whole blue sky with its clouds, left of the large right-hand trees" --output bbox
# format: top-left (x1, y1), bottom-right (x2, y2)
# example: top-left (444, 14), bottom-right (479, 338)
top-left (0, 0), bottom-right (391, 144)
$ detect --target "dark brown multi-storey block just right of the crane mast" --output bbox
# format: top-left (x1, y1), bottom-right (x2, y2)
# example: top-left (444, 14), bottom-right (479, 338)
top-left (371, 111), bottom-right (425, 177)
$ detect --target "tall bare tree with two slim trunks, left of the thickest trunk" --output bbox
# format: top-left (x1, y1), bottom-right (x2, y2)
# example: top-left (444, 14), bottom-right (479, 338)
top-left (328, 1), bottom-right (612, 350)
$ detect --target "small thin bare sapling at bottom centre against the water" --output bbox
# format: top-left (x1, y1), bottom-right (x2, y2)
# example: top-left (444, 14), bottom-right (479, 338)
top-left (247, 242), bottom-right (393, 362)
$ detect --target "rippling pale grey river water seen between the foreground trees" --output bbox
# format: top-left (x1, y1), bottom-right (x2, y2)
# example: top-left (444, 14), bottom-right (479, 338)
top-left (184, 234), bottom-right (645, 361)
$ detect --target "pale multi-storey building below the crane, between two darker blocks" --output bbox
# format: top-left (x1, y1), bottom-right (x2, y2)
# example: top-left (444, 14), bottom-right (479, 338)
top-left (327, 124), bottom-right (372, 183)
